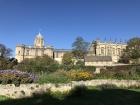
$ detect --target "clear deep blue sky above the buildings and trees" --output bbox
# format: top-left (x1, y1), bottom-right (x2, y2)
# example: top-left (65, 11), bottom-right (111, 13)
top-left (0, 0), bottom-right (140, 54)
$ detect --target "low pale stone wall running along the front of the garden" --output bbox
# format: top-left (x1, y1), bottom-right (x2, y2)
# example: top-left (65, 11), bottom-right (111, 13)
top-left (0, 80), bottom-right (140, 98)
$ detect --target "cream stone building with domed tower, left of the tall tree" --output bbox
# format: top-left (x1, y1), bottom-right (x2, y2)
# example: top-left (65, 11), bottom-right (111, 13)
top-left (16, 33), bottom-right (70, 63)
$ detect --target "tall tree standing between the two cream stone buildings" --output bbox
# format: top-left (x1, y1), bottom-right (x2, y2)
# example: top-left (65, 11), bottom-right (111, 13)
top-left (72, 37), bottom-right (89, 59)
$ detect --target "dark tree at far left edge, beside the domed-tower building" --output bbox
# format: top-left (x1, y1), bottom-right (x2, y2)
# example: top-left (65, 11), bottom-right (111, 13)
top-left (0, 44), bottom-right (12, 58)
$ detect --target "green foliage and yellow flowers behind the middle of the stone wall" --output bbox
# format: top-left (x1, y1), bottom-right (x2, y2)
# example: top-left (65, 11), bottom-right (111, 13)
top-left (37, 70), bottom-right (94, 84)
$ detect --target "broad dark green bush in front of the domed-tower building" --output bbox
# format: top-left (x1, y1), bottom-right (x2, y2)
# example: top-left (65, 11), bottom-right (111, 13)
top-left (16, 55), bottom-right (59, 73)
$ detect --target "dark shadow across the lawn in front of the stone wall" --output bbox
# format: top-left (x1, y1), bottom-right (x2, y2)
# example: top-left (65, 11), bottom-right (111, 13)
top-left (0, 89), bottom-right (140, 105)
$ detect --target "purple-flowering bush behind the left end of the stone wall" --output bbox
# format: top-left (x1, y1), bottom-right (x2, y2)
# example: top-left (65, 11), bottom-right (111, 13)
top-left (0, 70), bottom-right (35, 86)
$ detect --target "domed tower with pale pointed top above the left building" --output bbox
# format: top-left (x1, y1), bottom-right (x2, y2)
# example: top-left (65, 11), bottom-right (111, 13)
top-left (34, 33), bottom-right (44, 48)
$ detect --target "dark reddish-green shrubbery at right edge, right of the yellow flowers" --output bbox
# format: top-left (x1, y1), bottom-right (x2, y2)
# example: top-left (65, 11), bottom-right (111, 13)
top-left (95, 65), bottom-right (140, 80)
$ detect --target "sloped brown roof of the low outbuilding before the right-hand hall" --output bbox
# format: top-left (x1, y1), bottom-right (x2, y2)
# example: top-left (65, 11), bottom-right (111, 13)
top-left (85, 56), bottom-right (112, 62)
